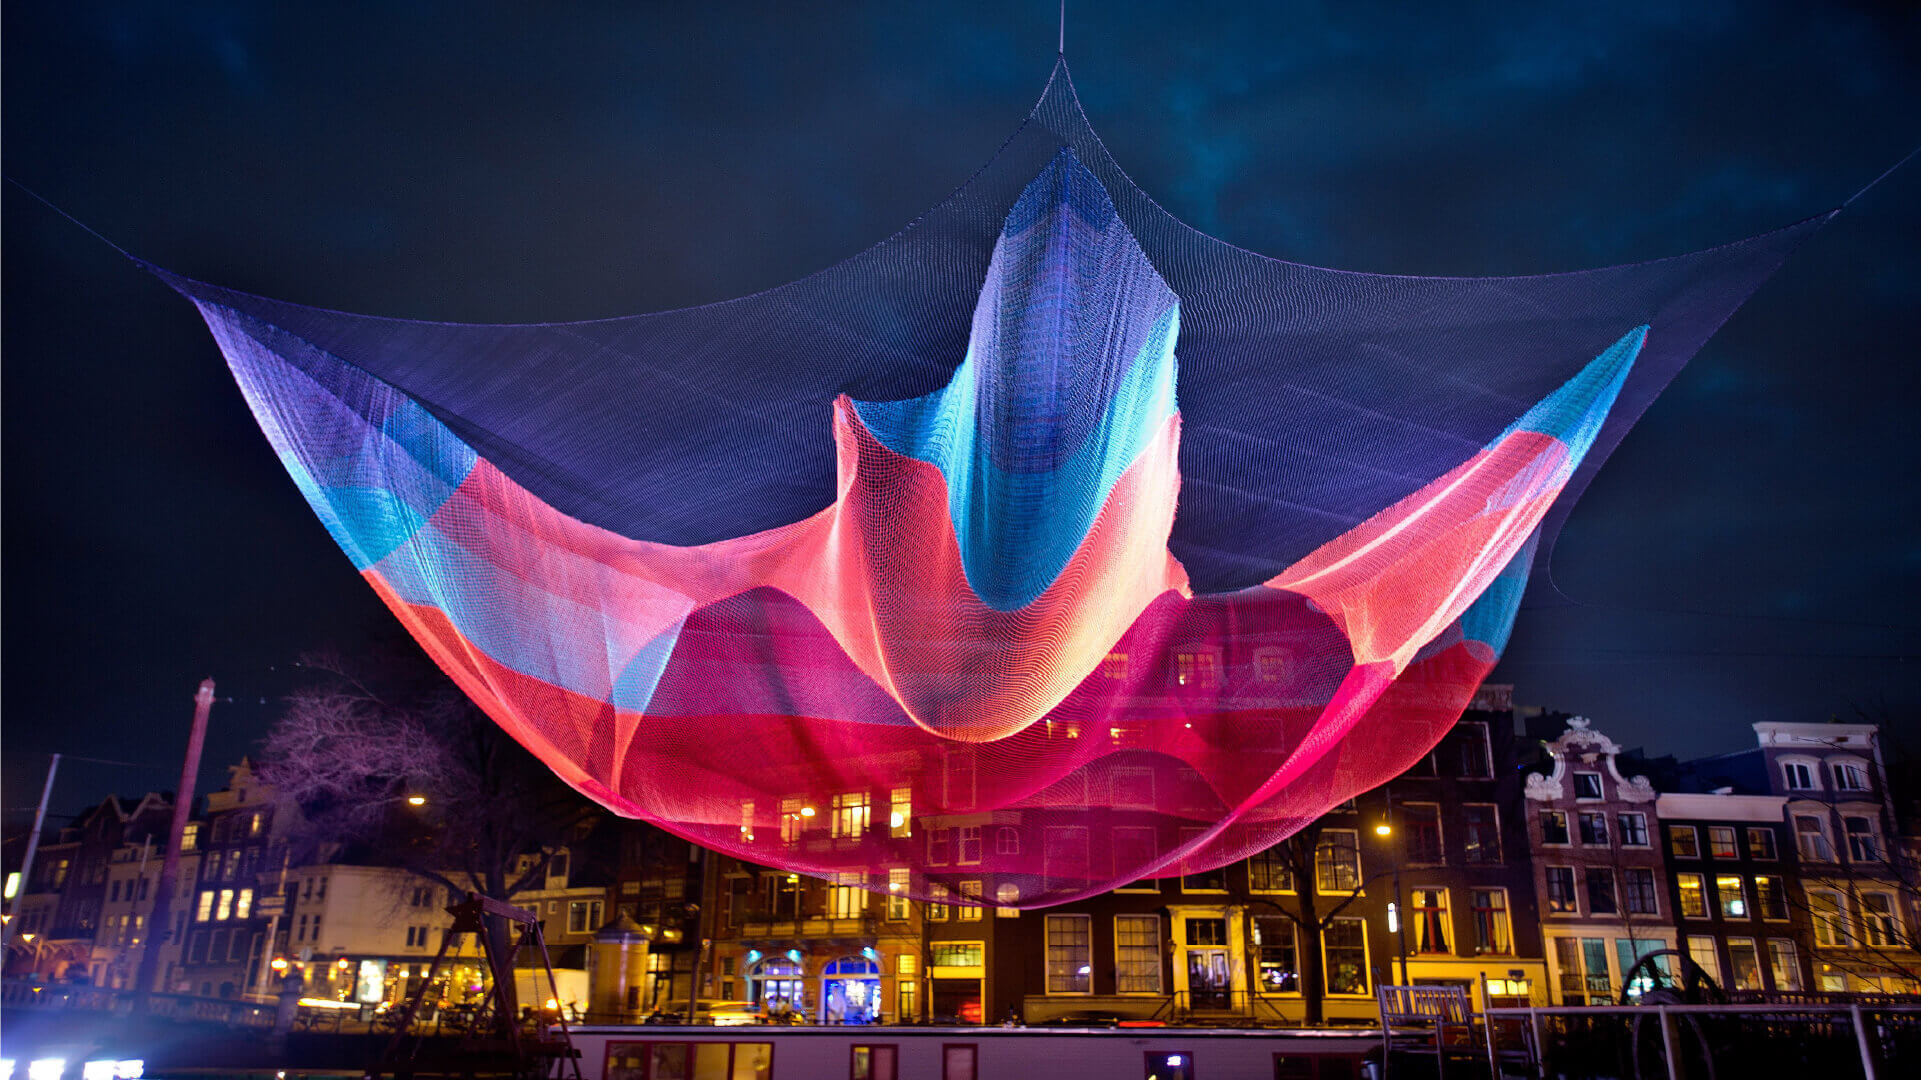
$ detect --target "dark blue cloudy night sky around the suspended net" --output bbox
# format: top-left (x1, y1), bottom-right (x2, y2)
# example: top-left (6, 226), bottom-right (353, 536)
top-left (0, 0), bottom-right (1921, 821)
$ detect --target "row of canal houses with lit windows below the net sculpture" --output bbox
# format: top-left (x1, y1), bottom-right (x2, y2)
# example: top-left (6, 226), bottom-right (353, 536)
top-left (8, 686), bottom-right (1921, 1024)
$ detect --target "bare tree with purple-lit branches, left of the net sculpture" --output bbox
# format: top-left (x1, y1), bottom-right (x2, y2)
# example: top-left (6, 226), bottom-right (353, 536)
top-left (259, 651), bottom-right (599, 1022)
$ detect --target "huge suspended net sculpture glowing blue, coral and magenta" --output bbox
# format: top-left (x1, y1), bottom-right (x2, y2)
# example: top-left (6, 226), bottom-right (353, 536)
top-left (156, 65), bottom-right (1827, 907)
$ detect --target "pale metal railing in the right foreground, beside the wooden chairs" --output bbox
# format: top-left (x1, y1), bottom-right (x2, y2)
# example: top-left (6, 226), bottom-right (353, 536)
top-left (1487, 1003), bottom-right (1921, 1080)
